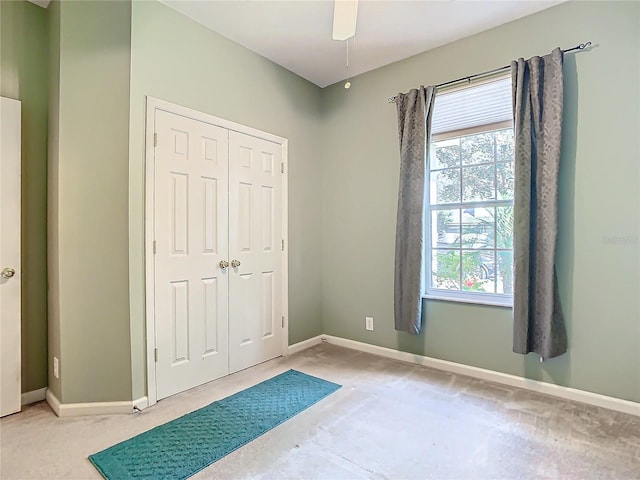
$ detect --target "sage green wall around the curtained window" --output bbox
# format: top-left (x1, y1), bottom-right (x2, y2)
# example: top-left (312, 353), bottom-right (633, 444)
top-left (322, 2), bottom-right (640, 401)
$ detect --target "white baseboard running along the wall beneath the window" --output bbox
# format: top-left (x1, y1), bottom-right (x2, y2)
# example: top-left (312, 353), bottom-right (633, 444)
top-left (320, 335), bottom-right (640, 416)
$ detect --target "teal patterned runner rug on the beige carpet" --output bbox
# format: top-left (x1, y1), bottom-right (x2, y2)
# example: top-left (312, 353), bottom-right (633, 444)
top-left (89, 370), bottom-right (341, 480)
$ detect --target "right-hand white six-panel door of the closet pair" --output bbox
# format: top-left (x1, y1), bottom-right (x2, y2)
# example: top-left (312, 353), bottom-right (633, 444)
top-left (229, 131), bottom-right (283, 373)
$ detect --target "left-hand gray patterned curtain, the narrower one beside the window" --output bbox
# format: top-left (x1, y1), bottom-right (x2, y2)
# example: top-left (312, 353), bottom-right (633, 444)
top-left (394, 87), bottom-right (435, 335)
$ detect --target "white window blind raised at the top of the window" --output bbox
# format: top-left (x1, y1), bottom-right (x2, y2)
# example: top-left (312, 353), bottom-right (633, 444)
top-left (431, 77), bottom-right (513, 135)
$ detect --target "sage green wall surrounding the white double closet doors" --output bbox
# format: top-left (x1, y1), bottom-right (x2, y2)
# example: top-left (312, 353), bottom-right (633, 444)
top-left (129, 2), bottom-right (322, 398)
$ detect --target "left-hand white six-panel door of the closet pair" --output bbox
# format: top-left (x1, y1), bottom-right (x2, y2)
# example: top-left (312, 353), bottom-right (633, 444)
top-left (154, 110), bottom-right (229, 399)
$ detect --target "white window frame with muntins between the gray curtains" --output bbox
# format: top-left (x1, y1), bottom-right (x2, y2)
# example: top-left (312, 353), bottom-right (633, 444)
top-left (422, 120), bottom-right (514, 308)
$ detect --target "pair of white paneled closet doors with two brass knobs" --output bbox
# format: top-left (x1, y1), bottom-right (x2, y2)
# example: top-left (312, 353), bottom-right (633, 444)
top-left (154, 110), bottom-right (282, 399)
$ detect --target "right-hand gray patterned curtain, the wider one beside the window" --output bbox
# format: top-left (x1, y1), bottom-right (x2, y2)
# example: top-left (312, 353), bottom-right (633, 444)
top-left (511, 48), bottom-right (567, 358)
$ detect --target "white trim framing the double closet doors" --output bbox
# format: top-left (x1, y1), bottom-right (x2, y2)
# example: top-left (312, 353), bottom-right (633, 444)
top-left (144, 96), bottom-right (289, 407)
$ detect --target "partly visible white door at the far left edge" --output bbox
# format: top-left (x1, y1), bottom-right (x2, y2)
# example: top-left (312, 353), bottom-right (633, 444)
top-left (0, 97), bottom-right (21, 416)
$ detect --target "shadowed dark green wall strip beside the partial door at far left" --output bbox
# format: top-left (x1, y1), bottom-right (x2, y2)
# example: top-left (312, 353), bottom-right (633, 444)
top-left (0, 0), bottom-right (48, 392)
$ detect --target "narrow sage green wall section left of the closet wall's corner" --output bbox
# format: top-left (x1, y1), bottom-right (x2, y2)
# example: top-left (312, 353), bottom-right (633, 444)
top-left (49, 1), bottom-right (132, 403)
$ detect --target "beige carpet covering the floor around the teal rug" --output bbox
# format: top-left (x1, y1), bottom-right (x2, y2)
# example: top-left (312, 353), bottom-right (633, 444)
top-left (0, 345), bottom-right (640, 480)
